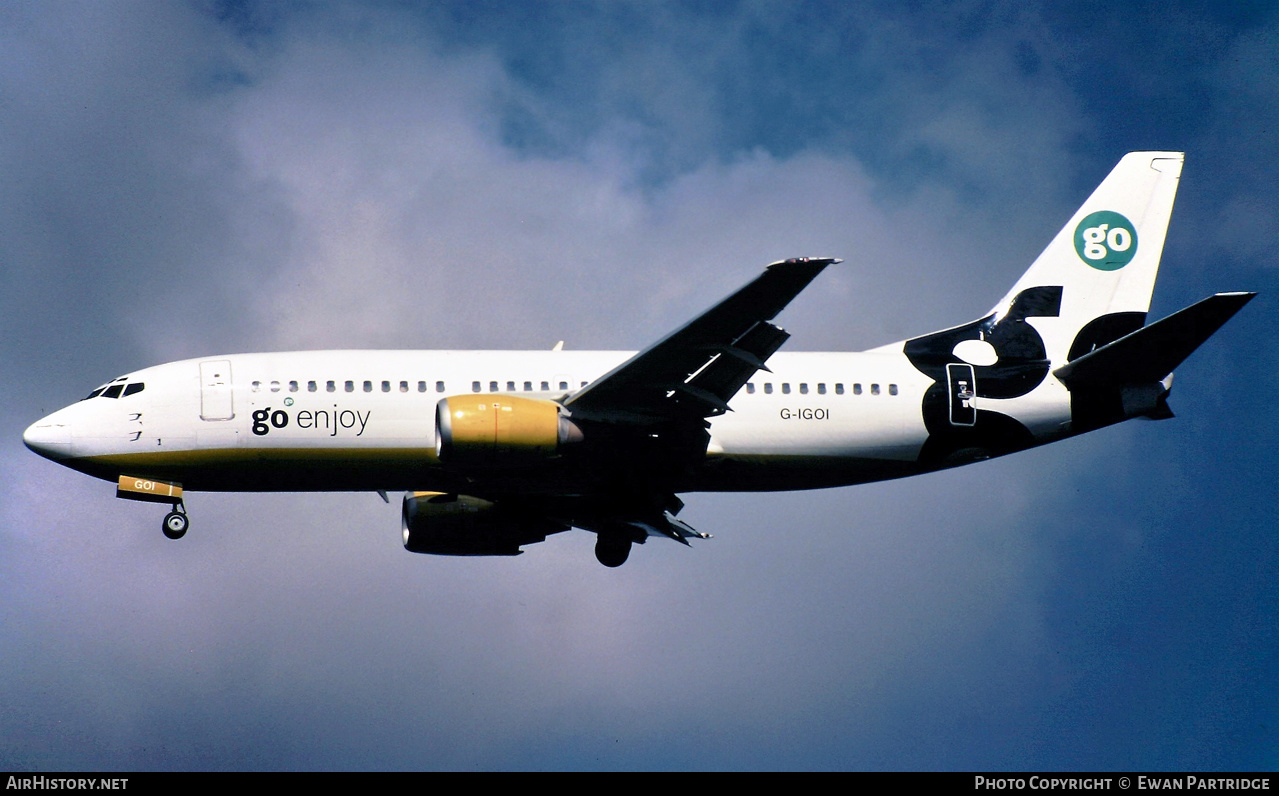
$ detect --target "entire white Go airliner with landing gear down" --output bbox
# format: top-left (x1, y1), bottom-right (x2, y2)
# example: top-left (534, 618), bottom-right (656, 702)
top-left (23, 152), bottom-right (1253, 567)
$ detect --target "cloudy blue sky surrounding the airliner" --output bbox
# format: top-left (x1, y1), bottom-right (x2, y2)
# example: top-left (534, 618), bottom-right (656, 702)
top-left (0, 1), bottom-right (1279, 770)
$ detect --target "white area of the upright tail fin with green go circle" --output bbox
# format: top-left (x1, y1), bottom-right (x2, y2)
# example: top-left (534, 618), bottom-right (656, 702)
top-left (991, 152), bottom-right (1184, 363)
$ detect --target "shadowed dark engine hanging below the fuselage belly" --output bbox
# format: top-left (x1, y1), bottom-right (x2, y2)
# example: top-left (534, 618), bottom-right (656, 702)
top-left (402, 491), bottom-right (567, 555)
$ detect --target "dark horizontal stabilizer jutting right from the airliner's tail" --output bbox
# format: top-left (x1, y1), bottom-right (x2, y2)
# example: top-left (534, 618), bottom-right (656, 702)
top-left (1053, 293), bottom-right (1256, 390)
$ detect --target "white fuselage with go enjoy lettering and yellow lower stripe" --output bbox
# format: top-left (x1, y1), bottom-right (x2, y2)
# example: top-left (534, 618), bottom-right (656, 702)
top-left (27, 344), bottom-right (1071, 491)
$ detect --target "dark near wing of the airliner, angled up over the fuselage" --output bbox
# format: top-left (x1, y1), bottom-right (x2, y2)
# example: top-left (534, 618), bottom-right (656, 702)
top-left (564, 257), bottom-right (839, 424)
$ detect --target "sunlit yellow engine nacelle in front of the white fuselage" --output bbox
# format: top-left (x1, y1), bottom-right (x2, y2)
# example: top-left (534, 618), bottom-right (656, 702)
top-left (435, 393), bottom-right (582, 467)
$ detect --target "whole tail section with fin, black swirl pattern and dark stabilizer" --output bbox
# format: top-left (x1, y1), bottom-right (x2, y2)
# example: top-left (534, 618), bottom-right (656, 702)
top-left (902, 152), bottom-right (1253, 455)
